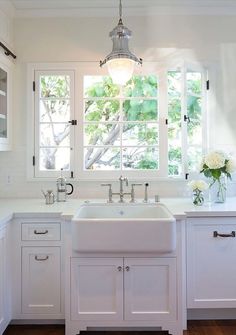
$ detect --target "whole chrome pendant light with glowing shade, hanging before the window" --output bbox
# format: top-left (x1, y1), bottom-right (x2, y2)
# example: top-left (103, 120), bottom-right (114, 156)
top-left (100, 0), bottom-right (142, 85)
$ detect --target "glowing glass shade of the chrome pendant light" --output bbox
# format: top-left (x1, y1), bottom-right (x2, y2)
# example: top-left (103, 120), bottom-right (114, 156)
top-left (107, 58), bottom-right (135, 85)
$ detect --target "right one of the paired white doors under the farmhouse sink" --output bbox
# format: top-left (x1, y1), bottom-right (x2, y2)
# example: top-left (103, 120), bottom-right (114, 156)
top-left (124, 258), bottom-right (176, 321)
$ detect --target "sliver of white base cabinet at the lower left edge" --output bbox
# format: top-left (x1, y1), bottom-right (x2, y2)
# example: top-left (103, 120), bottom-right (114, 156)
top-left (0, 228), bottom-right (10, 334)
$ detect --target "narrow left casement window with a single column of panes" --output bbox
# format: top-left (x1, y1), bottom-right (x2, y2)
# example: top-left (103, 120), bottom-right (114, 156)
top-left (35, 71), bottom-right (74, 177)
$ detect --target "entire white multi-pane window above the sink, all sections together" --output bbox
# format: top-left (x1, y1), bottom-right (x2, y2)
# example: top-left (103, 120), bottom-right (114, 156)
top-left (31, 63), bottom-right (207, 180)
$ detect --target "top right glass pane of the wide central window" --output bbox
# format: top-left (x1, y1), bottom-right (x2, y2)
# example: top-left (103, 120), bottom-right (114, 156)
top-left (124, 75), bottom-right (157, 97)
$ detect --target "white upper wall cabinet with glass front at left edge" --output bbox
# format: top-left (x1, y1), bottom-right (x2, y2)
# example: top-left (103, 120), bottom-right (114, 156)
top-left (0, 55), bottom-right (12, 151)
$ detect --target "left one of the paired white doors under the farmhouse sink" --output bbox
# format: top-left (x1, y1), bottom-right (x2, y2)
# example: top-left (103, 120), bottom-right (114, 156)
top-left (71, 258), bottom-right (123, 320)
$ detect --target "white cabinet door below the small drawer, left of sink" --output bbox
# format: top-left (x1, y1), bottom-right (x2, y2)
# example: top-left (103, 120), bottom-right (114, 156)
top-left (22, 247), bottom-right (61, 314)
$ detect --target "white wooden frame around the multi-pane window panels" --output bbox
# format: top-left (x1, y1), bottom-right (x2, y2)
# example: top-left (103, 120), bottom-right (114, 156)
top-left (27, 61), bottom-right (209, 181)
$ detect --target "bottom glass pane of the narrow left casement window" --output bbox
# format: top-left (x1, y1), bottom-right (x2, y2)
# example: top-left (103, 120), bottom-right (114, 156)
top-left (39, 148), bottom-right (70, 171)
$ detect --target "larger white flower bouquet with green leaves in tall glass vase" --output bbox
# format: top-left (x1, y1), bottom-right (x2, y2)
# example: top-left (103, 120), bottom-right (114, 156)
top-left (200, 151), bottom-right (236, 202)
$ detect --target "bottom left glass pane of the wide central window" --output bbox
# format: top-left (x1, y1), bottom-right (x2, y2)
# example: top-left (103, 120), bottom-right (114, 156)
top-left (84, 148), bottom-right (120, 171)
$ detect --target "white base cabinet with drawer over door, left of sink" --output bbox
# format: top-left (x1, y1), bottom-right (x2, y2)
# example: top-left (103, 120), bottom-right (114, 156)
top-left (12, 215), bottom-right (64, 319)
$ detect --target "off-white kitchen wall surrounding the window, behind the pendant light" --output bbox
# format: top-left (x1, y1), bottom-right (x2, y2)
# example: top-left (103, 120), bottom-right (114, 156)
top-left (0, 16), bottom-right (236, 197)
